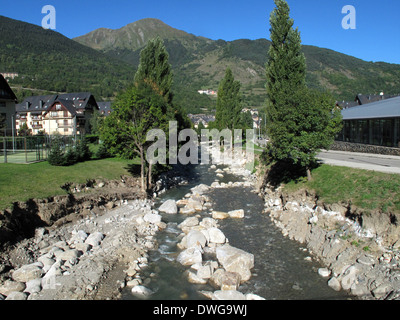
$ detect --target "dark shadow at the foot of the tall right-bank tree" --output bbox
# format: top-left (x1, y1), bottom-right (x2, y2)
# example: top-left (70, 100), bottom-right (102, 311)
top-left (265, 161), bottom-right (320, 188)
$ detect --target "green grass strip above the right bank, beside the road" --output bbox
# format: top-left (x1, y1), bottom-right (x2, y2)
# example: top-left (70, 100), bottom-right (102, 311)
top-left (285, 165), bottom-right (400, 213)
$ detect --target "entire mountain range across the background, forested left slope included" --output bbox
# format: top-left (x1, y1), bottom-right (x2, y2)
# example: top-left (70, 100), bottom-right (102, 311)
top-left (0, 16), bottom-right (400, 113)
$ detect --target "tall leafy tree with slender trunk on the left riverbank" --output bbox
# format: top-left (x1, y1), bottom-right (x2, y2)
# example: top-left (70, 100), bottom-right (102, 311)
top-left (101, 38), bottom-right (176, 191)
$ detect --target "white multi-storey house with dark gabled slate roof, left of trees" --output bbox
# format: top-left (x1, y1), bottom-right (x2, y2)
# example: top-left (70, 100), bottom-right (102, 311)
top-left (16, 92), bottom-right (99, 135)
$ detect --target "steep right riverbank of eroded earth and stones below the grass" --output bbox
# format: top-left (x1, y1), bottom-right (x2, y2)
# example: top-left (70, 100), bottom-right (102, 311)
top-left (259, 168), bottom-right (400, 300)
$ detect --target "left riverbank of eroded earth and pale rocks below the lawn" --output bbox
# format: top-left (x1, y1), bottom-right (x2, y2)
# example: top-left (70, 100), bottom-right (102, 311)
top-left (0, 172), bottom-right (165, 300)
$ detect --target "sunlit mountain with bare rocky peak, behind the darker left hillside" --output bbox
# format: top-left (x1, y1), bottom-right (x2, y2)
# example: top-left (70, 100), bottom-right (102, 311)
top-left (74, 19), bottom-right (400, 107)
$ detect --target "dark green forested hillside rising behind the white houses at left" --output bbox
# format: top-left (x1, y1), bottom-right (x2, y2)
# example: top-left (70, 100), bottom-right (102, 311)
top-left (0, 16), bottom-right (135, 101)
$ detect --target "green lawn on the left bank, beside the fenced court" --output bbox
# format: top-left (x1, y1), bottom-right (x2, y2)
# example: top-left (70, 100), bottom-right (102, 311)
top-left (0, 158), bottom-right (140, 210)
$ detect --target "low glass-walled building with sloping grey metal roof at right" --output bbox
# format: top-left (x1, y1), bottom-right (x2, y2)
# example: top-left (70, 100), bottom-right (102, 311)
top-left (337, 97), bottom-right (400, 148)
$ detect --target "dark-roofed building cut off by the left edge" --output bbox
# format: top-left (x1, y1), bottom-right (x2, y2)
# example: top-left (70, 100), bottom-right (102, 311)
top-left (0, 75), bottom-right (17, 136)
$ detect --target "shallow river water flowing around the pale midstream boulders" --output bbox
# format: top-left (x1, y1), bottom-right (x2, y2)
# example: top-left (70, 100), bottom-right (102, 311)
top-left (122, 165), bottom-right (349, 300)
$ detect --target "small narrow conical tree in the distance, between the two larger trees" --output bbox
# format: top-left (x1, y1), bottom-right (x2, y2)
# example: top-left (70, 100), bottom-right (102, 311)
top-left (215, 68), bottom-right (242, 130)
